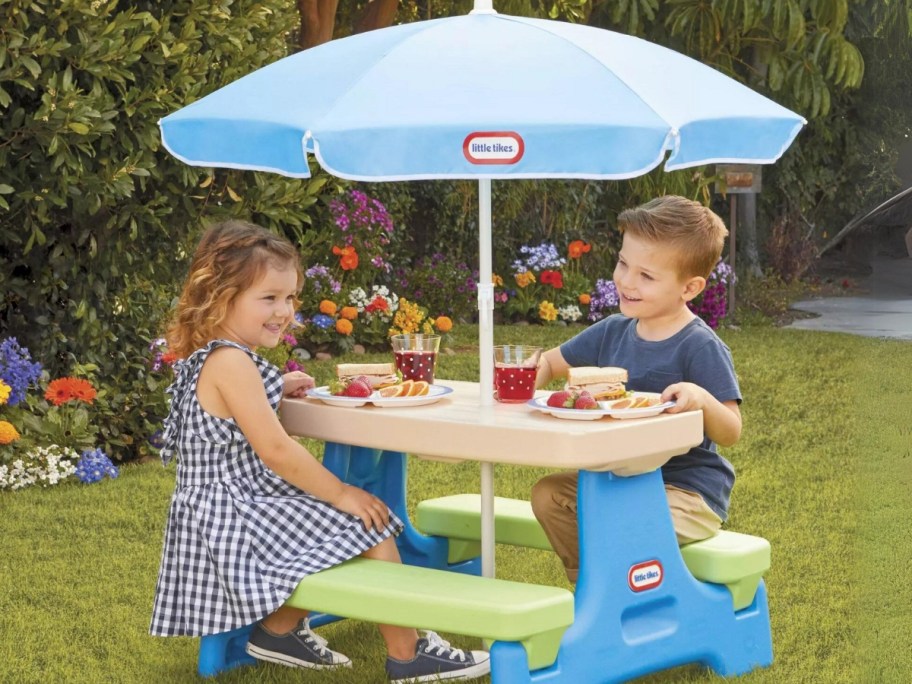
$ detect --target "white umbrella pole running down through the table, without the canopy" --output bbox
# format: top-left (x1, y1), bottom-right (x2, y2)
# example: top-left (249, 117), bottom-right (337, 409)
top-left (478, 178), bottom-right (494, 577)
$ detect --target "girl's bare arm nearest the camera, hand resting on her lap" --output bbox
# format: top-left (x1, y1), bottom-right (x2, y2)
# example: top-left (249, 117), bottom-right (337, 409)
top-left (197, 347), bottom-right (389, 529)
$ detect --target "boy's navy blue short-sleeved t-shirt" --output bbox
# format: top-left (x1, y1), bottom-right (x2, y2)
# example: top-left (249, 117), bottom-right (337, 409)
top-left (560, 314), bottom-right (741, 520)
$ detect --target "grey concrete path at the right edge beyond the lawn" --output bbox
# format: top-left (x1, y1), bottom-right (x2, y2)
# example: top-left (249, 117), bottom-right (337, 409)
top-left (786, 257), bottom-right (912, 340)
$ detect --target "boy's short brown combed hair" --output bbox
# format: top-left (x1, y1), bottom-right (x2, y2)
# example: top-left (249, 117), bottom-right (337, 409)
top-left (618, 195), bottom-right (728, 278)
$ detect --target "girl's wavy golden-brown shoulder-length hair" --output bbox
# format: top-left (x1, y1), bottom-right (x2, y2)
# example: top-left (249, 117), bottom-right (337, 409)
top-left (166, 220), bottom-right (304, 359)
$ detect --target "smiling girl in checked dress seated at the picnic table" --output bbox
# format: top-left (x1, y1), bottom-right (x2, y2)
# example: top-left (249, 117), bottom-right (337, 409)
top-left (150, 221), bottom-right (490, 682)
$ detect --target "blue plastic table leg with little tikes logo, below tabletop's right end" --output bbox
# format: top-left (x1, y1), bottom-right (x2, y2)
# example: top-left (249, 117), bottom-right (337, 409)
top-left (506, 471), bottom-right (772, 684)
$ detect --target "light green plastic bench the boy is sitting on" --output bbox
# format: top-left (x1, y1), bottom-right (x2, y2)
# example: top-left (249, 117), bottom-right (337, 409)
top-left (415, 494), bottom-right (770, 610)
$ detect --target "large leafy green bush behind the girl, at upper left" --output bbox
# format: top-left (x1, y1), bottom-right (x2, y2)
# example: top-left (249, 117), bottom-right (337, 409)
top-left (0, 0), bottom-right (335, 459)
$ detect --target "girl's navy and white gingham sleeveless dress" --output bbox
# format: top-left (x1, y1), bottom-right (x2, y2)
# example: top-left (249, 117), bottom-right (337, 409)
top-left (150, 340), bottom-right (402, 636)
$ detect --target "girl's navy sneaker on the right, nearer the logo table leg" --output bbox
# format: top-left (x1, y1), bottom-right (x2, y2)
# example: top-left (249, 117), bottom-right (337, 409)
top-left (386, 632), bottom-right (491, 684)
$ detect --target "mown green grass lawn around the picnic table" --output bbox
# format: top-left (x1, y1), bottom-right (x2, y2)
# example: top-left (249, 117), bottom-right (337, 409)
top-left (0, 326), bottom-right (912, 684)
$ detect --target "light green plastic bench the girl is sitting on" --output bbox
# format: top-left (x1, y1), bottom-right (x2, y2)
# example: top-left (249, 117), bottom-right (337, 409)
top-left (199, 558), bottom-right (573, 676)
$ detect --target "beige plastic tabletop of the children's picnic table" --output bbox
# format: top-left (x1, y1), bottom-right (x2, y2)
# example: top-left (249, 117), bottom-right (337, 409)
top-left (281, 379), bottom-right (703, 475)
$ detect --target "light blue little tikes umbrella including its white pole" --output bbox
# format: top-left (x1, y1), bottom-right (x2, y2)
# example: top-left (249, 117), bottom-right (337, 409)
top-left (161, 0), bottom-right (805, 574)
